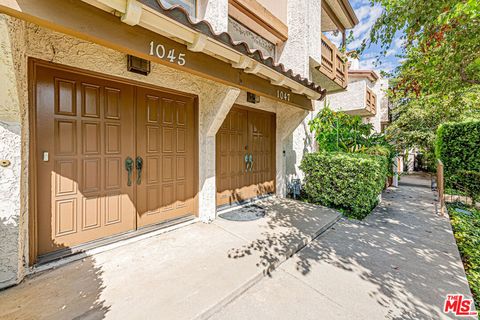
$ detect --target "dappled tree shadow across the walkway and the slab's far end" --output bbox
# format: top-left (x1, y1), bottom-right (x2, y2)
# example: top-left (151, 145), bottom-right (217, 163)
top-left (225, 177), bottom-right (471, 319)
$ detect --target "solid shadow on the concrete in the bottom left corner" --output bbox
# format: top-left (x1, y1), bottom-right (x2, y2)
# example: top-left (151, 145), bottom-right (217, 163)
top-left (0, 250), bottom-right (110, 319)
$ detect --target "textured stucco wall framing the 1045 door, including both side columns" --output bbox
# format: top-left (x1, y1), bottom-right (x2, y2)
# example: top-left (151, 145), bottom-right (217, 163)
top-left (0, 15), bottom-right (246, 287)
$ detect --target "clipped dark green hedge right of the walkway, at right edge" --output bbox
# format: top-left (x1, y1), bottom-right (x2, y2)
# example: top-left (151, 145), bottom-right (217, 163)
top-left (435, 120), bottom-right (480, 187)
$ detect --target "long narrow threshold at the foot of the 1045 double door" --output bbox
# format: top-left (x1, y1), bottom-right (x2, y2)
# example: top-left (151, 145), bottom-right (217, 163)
top-left (28, 215), bottom-right (200, 274)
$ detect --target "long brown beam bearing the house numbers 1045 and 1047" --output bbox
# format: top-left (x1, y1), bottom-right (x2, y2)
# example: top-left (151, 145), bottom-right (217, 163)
top-left (0, 0), bottom-right (313, 110)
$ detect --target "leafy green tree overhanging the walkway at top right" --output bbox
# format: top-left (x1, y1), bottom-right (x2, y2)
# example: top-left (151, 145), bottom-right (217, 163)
top-left (360, 0), bottom-right (480, 152)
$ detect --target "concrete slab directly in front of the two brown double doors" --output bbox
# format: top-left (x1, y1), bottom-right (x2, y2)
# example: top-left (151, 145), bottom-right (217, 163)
top-left (0, 198), bottom-right (340, 319)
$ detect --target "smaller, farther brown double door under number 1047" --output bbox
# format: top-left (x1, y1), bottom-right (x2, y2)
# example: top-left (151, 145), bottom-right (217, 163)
top-left (216, 106), bottom-right (276, 206)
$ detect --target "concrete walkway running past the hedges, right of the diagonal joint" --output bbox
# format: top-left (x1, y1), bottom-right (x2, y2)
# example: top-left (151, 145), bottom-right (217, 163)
top-left (213, 176), bottom-right (471, 320)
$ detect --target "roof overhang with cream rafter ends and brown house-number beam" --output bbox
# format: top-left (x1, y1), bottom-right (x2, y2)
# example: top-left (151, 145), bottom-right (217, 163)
top-left (0, 0), bottom-right (326, 110)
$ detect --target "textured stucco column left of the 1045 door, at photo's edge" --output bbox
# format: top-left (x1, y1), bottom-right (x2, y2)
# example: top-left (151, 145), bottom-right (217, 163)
top-left (0, 15), bottom-right (27, 288)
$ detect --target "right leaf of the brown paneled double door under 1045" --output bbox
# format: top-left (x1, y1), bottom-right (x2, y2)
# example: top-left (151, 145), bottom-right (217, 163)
top-left (136, 88), bottom-right (196, 227)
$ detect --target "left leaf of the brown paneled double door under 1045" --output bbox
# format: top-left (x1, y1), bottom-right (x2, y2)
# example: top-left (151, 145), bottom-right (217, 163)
top-left (35, 66), bottom-right (135, 255)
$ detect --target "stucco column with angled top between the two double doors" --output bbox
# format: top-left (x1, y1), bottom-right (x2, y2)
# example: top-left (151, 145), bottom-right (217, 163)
top-left (199, 88), bottom-right (240, 222)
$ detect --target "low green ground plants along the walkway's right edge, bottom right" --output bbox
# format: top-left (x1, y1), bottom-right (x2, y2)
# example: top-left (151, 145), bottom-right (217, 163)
top-left (448, 203), bottom-right (480, 310)
